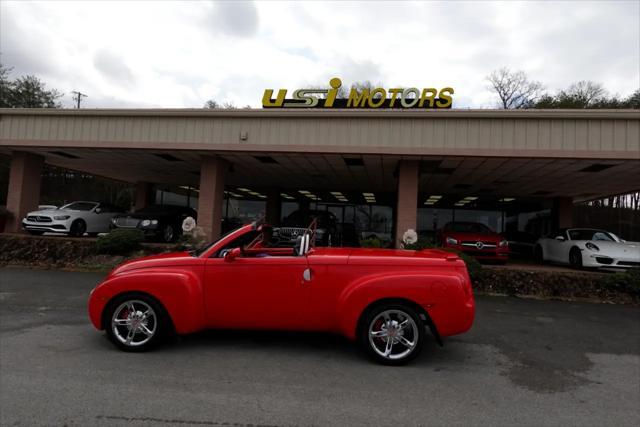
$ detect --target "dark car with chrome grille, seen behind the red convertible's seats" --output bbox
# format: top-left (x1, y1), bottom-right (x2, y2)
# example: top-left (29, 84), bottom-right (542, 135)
top-left (274, 209), bottom-right (340, 246)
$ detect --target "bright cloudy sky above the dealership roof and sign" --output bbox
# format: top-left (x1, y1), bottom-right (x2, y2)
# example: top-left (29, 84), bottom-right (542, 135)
top-left (0, 0), bottom-right (640, 108)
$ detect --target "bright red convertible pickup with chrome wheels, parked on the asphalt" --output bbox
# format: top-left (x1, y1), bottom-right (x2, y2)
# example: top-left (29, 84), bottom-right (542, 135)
top-left (89, 223), bottom-right (474, 365)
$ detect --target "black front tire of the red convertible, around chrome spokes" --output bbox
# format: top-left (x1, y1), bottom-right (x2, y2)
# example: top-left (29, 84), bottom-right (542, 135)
top-left (102, 293), bottom-right (173, 352)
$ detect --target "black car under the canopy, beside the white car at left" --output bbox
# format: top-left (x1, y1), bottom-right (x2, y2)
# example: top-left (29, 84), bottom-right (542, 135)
top-left (111, 205), bottom-right (198, 243)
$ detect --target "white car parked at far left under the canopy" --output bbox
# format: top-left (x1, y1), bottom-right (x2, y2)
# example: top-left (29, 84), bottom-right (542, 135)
top-left (22, 202), bottom-right (124, 237)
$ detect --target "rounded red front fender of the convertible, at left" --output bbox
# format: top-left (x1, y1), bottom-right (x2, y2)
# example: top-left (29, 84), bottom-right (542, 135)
top-left (89, 267), bottom-right (205, 334)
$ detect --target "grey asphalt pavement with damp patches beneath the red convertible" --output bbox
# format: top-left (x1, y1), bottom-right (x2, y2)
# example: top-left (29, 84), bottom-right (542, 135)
top-left (0, 268), bottom-right (640, 426)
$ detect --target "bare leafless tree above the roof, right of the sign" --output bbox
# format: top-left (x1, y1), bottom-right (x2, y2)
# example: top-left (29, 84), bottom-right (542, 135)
top-left (486, 67), bottom-right (544, 109)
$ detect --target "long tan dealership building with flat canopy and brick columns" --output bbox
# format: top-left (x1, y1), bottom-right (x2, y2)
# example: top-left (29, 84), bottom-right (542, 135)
top-left (0, 108), bottom-right (640, 244)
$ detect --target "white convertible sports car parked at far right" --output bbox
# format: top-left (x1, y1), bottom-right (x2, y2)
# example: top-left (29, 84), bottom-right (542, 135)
top-left (534, 228), bottom-right (640, 268)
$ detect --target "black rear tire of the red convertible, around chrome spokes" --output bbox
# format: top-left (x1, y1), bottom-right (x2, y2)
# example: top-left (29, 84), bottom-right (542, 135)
top-left (358, 303), bottom-right (426, 366)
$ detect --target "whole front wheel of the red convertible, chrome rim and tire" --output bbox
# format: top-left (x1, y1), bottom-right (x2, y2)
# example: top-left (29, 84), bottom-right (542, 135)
top-left (103, 293), bottom-right (172, 352)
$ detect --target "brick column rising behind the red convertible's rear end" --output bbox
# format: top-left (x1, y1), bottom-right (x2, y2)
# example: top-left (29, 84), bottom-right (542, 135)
top-left (395, 160), bottom-right (420, 248)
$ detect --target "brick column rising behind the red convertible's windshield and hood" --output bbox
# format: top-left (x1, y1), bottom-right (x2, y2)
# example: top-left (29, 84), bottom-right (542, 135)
top-left (198, 156), bottom-right (228, 240)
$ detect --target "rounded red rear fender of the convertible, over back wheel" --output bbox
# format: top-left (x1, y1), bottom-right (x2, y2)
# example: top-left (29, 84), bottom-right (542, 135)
top-left (338, 271), bottom-right (473, 339)
